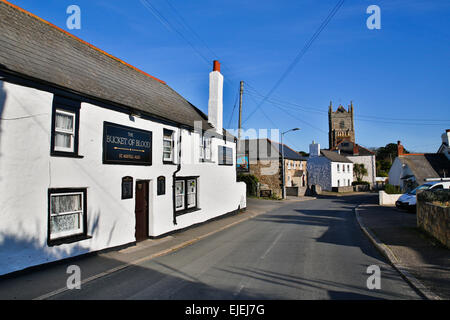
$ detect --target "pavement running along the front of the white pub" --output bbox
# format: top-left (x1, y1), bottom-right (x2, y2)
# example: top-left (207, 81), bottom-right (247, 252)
top-left (0, 197), bottom-right (315, 300)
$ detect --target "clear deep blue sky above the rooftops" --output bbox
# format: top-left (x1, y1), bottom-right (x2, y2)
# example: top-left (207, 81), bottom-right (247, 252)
top-left (10, 0), bottom-right (450, 152)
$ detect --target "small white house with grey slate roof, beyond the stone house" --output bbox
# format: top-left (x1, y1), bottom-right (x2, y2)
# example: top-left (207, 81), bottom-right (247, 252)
top-left (307, 141), bottom-right (353, 192)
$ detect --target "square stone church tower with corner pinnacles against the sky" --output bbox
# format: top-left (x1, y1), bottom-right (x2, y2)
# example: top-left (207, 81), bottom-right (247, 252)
top-left (328, 101), bottom-right (355, 149)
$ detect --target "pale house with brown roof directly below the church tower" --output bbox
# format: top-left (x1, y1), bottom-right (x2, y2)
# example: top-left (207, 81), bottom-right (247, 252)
top-left (331, 140), bottom-right (377, 188)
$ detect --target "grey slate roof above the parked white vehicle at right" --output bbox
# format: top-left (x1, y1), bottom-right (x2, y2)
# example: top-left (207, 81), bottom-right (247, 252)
top-left (399, 153), bottom-right (450, 183)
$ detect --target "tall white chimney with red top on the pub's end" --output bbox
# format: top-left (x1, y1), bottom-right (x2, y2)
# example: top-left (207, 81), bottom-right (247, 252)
top-left (208, 60), bottom-right (223, 134)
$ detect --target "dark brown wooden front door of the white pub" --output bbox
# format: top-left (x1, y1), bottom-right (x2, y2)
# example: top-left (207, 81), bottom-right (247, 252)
top-left (135, 181), bottom-right (148, 241)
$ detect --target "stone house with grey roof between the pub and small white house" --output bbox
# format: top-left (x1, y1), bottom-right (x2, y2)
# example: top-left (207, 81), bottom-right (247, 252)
top-left (242, 138), bottom-right (307, 197)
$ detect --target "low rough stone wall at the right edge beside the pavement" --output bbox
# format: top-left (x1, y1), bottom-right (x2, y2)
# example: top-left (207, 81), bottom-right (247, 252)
top-left (417, 201), bottom-right (450, 249)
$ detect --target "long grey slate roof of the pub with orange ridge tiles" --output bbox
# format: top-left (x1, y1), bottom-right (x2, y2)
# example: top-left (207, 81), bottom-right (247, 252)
top-left (0, 0), bottom-right (216, 132)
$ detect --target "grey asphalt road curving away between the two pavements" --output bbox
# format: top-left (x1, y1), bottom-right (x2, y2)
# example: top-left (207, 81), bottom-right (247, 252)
top-left (52, 196), bottom-right (420, 300)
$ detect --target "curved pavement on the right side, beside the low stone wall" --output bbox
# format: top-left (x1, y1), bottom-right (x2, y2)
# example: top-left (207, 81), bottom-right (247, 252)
top-left (356, 204), bottom-right (450, 300)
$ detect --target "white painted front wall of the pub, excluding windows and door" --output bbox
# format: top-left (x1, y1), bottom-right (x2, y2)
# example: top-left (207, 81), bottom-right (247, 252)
top-left (0, 82), bottom-right (246, 274)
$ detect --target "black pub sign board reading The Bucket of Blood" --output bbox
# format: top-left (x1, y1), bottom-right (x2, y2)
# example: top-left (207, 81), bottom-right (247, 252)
top-left (103, 121), bottom-right (152, 166)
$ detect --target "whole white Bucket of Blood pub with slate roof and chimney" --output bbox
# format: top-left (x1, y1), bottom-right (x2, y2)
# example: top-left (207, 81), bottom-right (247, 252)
top-left (0, 1), bottom-right (246, 274)
